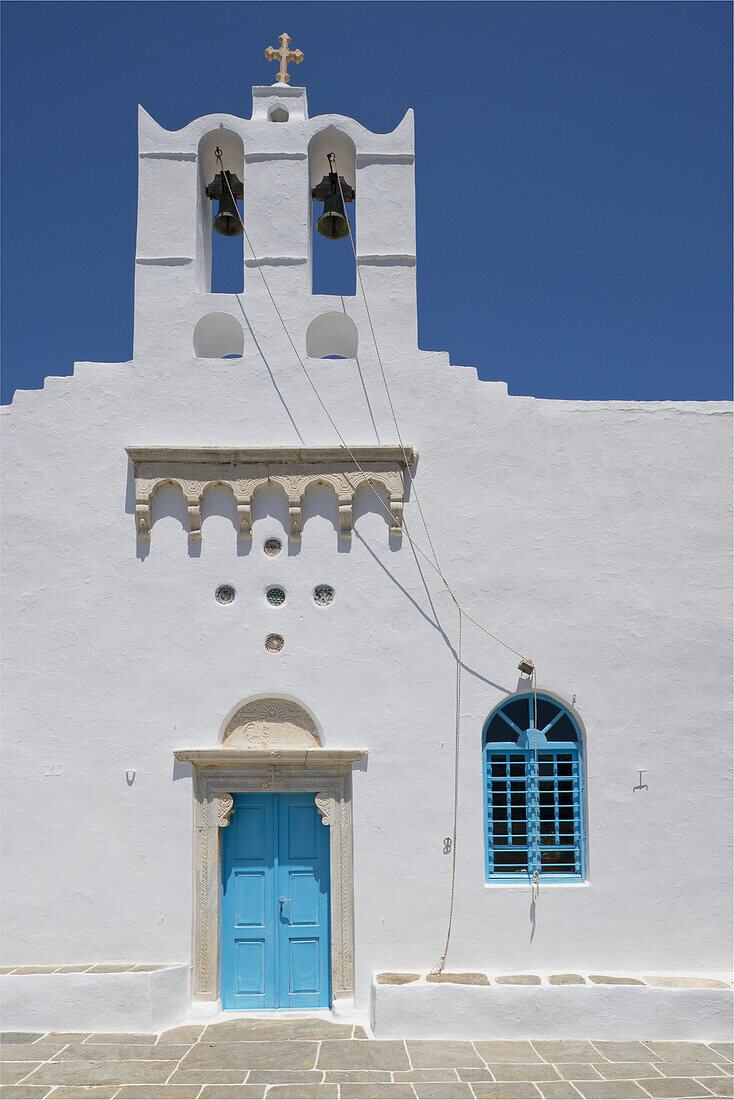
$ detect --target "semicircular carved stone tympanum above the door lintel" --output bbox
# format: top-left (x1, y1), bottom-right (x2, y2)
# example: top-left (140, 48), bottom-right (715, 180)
top-left (222, 695), bottom-right (321, 749)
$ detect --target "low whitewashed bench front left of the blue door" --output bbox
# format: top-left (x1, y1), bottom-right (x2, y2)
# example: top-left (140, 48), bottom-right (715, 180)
top-left (0, 966), bottom-right (191, 1034)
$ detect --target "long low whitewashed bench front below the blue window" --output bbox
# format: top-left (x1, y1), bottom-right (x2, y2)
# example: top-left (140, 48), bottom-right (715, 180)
top-left (371, 981), bottom-right (732, 1043)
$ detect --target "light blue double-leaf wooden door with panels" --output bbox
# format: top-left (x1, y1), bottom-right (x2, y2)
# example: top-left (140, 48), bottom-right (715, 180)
top-left (221, 793), bottom-right (331, 1009)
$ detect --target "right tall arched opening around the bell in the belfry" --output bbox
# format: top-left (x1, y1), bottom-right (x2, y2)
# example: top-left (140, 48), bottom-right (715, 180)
top-left (308, 127), bottom-right (357, 296)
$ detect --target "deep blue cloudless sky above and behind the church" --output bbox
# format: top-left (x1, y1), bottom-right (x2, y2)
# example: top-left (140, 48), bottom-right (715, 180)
top-left (2, 0), bottom-right (732, 403)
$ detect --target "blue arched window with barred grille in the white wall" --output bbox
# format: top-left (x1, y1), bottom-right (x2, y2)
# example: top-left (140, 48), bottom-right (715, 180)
top-left (483, 693), bottom-right (585, 882)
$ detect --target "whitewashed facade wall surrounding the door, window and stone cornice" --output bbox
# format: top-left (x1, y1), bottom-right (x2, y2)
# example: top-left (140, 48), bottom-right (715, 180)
top-left (2, 89), bottom-right (732, 1020)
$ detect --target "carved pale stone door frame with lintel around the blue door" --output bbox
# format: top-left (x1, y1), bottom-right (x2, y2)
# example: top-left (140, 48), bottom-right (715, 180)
top-left (174, 749), bottom-right (366, 1001)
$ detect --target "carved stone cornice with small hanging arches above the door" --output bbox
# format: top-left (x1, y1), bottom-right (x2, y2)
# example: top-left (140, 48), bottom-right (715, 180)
top-left (125, 447), bottom-right (417, 541)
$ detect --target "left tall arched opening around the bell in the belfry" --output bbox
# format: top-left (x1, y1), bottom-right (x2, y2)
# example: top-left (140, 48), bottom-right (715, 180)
top-left (197, 129), bottom-right (244, 294)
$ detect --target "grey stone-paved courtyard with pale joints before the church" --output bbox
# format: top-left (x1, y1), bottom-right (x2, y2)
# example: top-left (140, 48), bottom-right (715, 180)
top-left (0, 1019), bottom-right (734, 1100)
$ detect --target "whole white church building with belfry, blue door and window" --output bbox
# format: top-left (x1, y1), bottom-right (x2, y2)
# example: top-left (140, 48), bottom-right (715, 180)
top-left (0, 62), bottom-right (732, 1041)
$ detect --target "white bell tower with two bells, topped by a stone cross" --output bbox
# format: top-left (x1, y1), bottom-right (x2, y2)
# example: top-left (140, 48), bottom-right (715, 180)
top-left (134, 60), bottom-right (417, 370)
